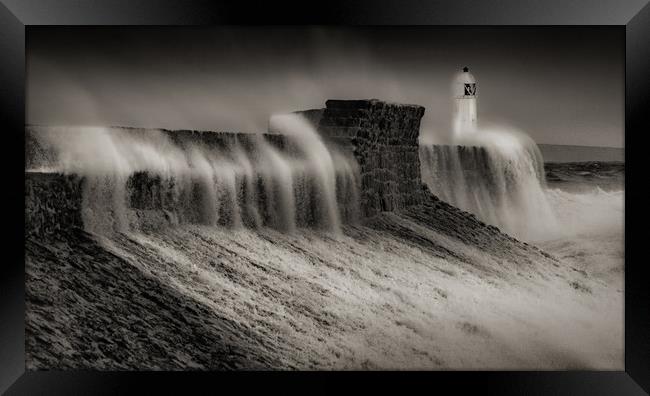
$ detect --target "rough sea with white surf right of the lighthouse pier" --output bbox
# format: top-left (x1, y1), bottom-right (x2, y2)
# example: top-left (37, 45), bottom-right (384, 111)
top-left (540, 161), bottom-right (625, 290)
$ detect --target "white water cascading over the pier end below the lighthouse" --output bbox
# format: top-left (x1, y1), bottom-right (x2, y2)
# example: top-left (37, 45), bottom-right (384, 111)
top-left (420, 129), bottom-right (557, 241)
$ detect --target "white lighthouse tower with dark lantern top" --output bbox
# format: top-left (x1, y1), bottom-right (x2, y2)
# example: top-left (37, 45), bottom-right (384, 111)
top-left (453, 66), bottom-right (476, 138)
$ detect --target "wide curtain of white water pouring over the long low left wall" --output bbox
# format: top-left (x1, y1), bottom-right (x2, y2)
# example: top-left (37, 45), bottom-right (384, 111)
top-left (28, 115), bottom-right (360, 234)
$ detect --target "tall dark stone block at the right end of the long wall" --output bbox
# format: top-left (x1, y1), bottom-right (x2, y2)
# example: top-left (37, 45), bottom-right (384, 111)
top-left (298, 99), bottom-right (429, 216)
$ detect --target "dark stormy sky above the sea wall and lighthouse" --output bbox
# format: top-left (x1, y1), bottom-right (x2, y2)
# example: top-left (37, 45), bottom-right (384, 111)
top-left (26, 26), bottom-right (624, 147)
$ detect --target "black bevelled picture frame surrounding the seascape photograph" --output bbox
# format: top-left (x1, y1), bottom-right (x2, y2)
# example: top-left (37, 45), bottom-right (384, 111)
top-left (0, 0), bottom-right (650, 395)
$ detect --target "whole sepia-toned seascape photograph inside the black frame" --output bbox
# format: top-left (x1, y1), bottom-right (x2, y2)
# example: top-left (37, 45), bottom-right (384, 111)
top-left (20, 26), bottom-right (625, 371)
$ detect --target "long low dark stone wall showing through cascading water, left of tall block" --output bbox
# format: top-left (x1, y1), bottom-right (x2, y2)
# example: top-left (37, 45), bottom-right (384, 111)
top-left (25, 126), bottom-right (296, 237)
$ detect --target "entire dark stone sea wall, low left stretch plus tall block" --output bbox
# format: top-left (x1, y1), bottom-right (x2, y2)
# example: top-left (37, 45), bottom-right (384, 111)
top-left (25, 99), bottom-right (430, 234)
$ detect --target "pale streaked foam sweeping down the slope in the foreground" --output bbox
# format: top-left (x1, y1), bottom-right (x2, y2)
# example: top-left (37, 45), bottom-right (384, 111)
top-left (90, 214), bottom-right (622, 369)
